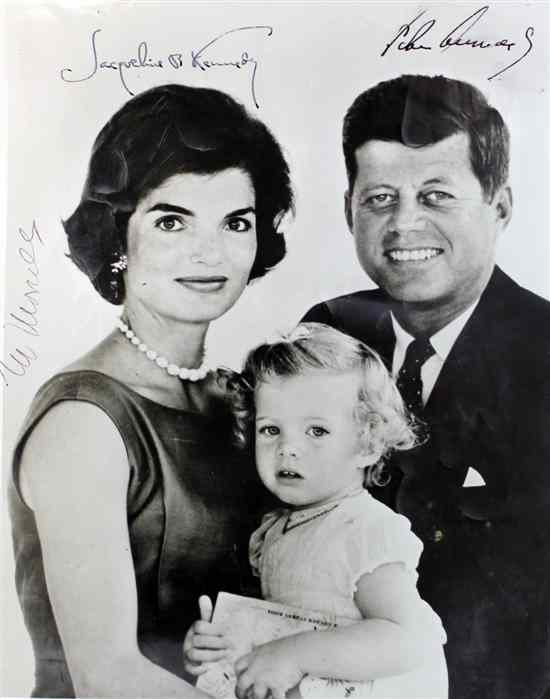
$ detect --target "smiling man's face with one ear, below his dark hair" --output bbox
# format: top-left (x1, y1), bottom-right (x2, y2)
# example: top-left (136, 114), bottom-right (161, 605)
top-left (346, 133), bottom-right (511, 315)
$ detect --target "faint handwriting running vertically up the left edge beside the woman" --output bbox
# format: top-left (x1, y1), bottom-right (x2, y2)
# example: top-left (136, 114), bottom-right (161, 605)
top-left (0, 221), bottom-right (44, 386)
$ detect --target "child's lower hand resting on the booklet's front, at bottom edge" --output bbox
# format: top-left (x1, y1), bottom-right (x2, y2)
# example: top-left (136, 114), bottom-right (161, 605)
top-left (235, 636), bottom-right (304, 699)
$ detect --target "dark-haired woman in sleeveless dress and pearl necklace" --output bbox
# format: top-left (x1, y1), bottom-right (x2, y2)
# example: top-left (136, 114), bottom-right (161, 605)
top-left (9, 85), bottom-right (292, 697)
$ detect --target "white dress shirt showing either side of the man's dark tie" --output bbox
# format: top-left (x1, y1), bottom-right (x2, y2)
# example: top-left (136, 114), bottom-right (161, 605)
top-left (391, 299), bottom-right (479, 405)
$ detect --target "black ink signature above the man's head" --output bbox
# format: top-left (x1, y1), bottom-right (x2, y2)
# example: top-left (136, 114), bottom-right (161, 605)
top-left (380, 5), bottom-right (535, 80)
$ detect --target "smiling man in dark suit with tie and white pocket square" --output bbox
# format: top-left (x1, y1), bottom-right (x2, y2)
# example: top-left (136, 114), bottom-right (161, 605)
top-left (304, 76), bottom-right (550, 699)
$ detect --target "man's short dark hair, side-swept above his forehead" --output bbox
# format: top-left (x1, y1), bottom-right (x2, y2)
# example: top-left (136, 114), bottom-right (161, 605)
top-left (343, 75), bottom-right (510, 201)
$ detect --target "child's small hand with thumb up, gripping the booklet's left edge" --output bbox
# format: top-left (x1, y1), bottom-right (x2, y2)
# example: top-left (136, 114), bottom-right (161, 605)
top-left (183, 595), bottom-right (229, 676)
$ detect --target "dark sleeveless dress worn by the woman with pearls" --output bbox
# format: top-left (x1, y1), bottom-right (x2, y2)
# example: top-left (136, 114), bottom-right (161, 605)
top-left (8, 371), bottom-right (262, 697)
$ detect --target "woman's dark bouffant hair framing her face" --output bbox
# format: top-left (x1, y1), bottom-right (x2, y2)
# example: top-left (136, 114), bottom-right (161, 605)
top-left (63, 85), bottom-right (293, 304)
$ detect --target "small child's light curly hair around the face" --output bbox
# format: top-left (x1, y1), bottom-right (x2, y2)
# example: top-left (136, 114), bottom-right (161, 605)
top-left (229, 323), bottom-right (419, 486)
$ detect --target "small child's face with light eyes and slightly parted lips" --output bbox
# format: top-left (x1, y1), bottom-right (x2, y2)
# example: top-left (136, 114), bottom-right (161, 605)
top-left (255, 370), bottom-right (366, 507)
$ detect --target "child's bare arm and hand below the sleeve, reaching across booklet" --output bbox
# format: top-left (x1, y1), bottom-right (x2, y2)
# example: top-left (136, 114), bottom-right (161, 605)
top-left (235, 563), bottom-right (439, 699)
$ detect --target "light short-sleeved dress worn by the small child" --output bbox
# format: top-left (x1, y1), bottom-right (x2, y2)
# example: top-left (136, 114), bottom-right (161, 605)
top-left (250, 490), bottom-right (447, 699)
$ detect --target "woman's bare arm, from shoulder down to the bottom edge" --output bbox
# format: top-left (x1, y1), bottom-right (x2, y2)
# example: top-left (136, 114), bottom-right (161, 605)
top-left (21, 402), bottom-right (206, 697)
